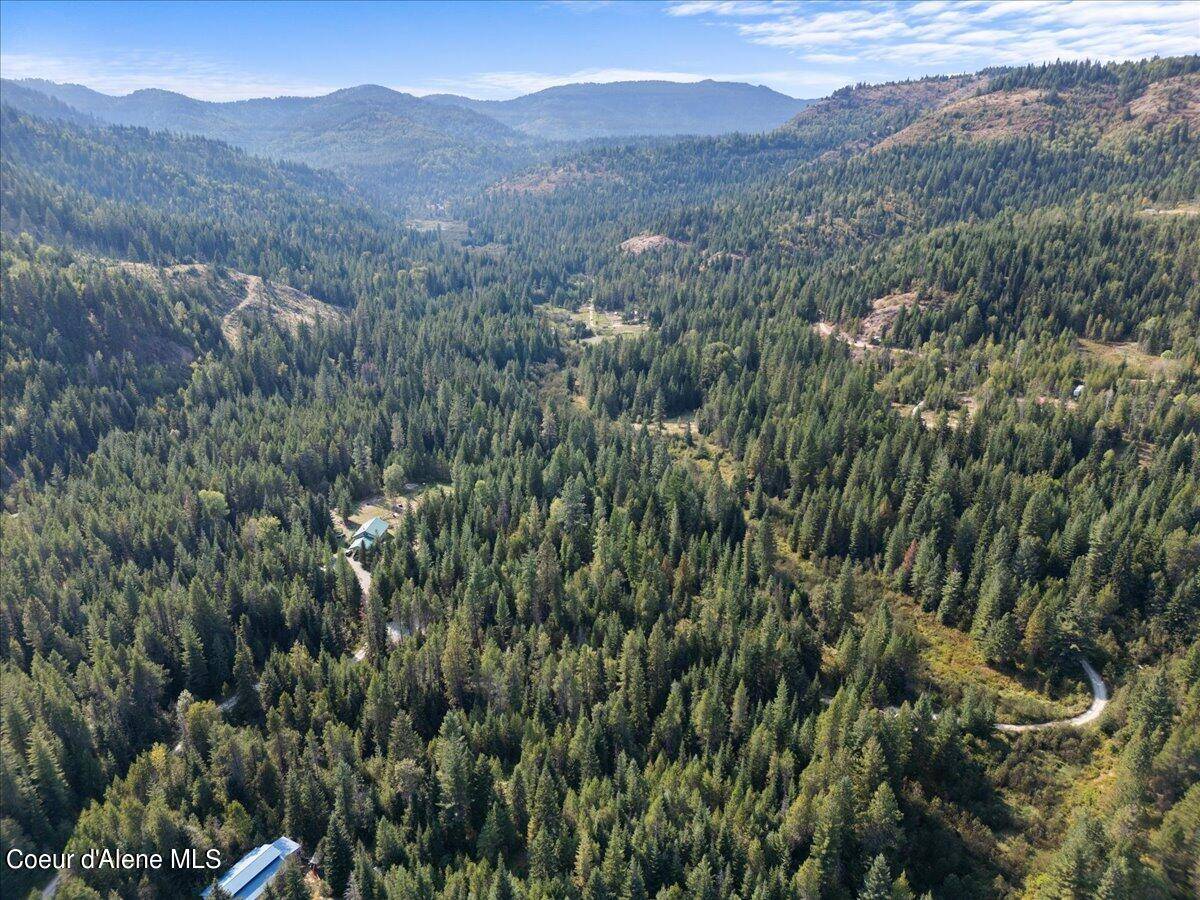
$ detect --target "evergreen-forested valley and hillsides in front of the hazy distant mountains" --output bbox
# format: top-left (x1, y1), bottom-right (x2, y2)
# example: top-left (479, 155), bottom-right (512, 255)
top-left (0, 58), bottom-right (1200, 900)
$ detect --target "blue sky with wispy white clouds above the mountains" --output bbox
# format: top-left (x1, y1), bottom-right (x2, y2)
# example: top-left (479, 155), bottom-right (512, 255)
top-left (0, 0), bottom-right (1200, 100)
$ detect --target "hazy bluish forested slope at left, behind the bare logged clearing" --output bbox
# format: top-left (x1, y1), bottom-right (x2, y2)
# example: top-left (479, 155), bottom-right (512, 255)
top-left (0, 107), bottom-right (444, 306)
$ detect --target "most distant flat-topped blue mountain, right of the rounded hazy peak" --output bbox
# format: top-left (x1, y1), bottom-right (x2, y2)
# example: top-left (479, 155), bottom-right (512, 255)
top-left (426, 80), bottom-right (810, 140)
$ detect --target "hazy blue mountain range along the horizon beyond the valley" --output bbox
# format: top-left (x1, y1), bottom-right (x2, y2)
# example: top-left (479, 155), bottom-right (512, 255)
top-left (2, 79), bottom-right (805, 206)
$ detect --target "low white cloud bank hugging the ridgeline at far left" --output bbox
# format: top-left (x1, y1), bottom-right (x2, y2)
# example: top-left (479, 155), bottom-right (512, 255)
top-left (0, 50), bottom-right (336, 101)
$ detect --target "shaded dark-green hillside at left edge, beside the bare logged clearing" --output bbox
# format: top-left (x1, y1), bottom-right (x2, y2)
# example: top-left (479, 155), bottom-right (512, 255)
top-left (0, 235), bottom-right (220, 482)
